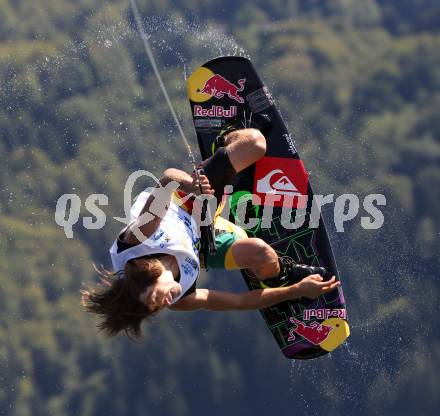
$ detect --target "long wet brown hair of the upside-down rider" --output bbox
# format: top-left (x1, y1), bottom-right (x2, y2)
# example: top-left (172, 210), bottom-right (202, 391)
top-left (81, 257), bottom-right (163, 341)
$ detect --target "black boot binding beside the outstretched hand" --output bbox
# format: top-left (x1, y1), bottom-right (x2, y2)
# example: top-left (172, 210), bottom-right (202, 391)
top-left (261, 256), bottom-right (331, 287)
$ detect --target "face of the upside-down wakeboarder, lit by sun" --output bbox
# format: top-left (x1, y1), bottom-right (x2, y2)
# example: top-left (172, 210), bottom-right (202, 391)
top-left (140, 271), bottom-right (182, 310)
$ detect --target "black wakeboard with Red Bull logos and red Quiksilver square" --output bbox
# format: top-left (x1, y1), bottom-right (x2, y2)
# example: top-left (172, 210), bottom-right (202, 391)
top-left (187, 56), bottom-right (350, 359)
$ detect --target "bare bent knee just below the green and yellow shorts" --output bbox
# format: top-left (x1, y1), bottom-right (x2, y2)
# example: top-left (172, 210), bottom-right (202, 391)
top-left (231, 238), bottom-right (280, 280)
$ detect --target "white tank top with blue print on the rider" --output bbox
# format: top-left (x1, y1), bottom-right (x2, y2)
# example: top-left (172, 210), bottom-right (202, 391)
top-left (110, 191), bottom-right (200, 303)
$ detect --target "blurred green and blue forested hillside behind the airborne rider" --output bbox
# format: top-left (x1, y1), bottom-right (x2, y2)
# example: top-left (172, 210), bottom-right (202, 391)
top-left (0, 0), bottom-right (440, 416)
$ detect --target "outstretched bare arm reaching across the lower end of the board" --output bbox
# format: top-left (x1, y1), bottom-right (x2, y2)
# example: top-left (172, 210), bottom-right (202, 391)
top-left (170, 275), bottom-right (340, 311)
